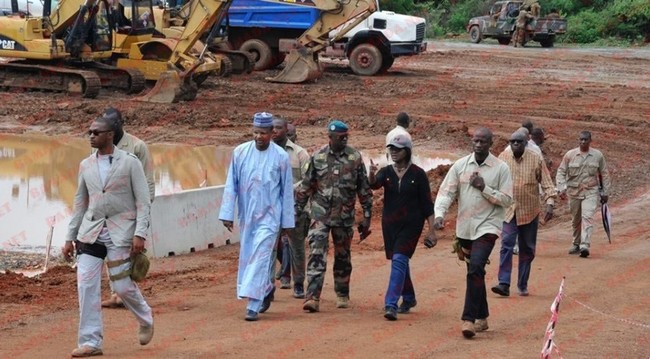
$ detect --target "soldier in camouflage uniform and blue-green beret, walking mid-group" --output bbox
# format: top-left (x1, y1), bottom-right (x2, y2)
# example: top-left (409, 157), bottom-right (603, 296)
top-left (296, 120), bottom-right (372, 313)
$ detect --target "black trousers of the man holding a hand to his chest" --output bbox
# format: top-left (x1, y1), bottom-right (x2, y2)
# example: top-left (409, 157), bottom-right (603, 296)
top-left (459, 233), bottom-right (498, 323)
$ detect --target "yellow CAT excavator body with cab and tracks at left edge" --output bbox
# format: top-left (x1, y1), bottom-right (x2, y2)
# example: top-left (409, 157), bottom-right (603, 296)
top-left (0, 0), bottom-right (147, 98)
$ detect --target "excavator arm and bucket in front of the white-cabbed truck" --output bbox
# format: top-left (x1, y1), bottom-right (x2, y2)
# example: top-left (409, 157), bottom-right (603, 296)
top-left (264, 0), bottom-right (377, 83)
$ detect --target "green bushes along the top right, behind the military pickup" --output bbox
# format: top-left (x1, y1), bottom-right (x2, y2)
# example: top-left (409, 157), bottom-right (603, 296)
top-left (380, 0), bottom-right (650, 44)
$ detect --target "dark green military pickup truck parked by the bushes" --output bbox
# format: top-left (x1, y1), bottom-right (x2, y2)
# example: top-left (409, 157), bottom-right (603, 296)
top-left (467, 1), bottom-right (566, 47)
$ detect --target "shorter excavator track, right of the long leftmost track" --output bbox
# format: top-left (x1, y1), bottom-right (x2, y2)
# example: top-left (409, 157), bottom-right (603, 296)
top-left (75, 61), bottom-right (146, 94)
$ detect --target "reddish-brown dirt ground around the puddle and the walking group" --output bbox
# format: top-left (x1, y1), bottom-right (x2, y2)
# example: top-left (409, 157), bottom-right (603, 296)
top-left (0, 43), bottom-right (650, 359)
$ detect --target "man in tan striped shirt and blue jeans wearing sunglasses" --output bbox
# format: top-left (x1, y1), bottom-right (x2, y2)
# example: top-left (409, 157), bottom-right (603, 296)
top-left (492, 131), bottom-right (556, 297)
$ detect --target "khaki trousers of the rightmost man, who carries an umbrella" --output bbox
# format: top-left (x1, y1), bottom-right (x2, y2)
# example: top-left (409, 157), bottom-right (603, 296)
top-left (569, 193), bottom-right (600, 249)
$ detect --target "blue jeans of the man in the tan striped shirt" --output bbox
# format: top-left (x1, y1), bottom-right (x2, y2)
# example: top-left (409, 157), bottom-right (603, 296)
top-left (499, 217), bottom-right (539, 291)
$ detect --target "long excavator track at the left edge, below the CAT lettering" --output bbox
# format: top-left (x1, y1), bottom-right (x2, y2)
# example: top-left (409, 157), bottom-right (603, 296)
top-left (0, 61), bottom-right (101, 98)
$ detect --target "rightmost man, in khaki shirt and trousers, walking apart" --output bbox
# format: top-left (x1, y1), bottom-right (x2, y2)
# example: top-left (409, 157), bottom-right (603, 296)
top-left (555, 131), bottom-right (611, 258)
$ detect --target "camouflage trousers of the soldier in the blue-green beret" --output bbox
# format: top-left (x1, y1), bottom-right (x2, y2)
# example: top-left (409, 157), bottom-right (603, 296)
top-left (305, 220), bottom-right (354, 299)
